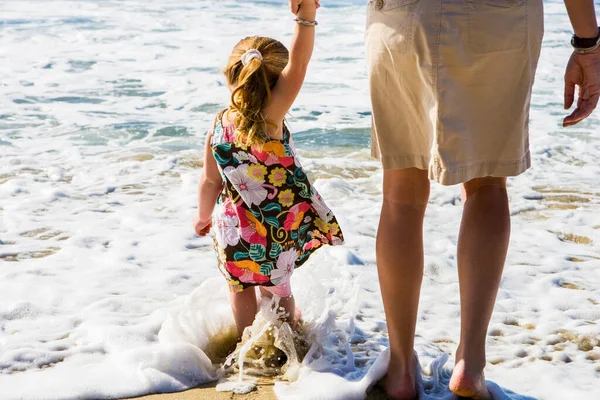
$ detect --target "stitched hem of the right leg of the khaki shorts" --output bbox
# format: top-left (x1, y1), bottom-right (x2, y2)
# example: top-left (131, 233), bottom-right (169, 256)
top-left (429, 152), bottom-right (531, 186)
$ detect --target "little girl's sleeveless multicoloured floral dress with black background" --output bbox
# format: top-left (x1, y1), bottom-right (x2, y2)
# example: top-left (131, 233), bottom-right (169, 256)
top-left (211, 113), bottom-right (344, 292)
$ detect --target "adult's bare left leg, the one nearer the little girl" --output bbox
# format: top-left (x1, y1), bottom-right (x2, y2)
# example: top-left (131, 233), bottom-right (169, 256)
top-left (376, 168), bottom-right (429, 399)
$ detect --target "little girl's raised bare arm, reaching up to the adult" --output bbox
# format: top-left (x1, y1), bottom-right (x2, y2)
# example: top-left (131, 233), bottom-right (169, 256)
top-left (263, 0), bottom-right (319, 125)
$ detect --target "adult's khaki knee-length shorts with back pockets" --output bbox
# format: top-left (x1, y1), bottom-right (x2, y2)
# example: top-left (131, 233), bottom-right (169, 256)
top-left (366, 0), bottom-right (544, 185)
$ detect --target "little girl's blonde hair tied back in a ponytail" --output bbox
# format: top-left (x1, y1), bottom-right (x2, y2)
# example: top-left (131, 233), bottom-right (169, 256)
top-left (223, 36), bottom-right (289, 146)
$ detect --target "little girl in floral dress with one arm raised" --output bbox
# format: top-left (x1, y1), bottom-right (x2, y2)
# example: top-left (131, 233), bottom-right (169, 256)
top-left (194, 0), bottom-right (343, 336)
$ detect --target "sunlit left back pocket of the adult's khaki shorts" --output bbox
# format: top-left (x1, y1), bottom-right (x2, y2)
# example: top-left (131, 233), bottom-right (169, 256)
top-left (366, 0), bottom-right (419, 53)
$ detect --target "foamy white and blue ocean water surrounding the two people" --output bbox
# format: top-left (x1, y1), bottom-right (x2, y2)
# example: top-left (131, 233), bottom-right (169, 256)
top-left (0, 0), bottom-right (600, 399)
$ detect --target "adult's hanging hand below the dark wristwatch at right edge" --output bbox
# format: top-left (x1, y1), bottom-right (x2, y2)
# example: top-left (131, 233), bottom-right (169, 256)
top-left (563, 49), bottom-right (600, 127)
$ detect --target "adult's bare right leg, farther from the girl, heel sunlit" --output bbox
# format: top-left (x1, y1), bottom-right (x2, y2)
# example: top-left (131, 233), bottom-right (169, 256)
top-left (450, 177), bottom-right (510, 399)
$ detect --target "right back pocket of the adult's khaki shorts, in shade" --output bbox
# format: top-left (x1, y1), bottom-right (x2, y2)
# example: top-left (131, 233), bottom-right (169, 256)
top-left (465, 0), bottom-right (528, 53)
